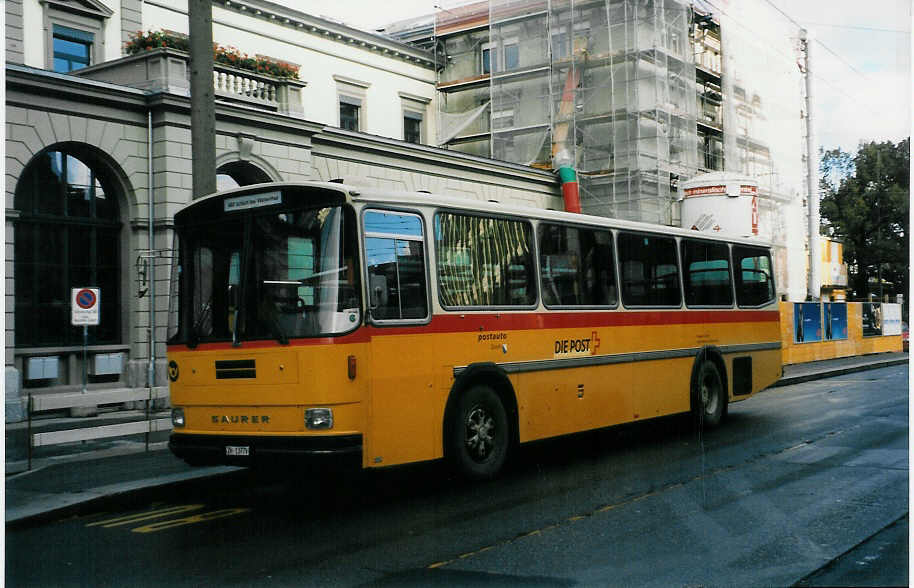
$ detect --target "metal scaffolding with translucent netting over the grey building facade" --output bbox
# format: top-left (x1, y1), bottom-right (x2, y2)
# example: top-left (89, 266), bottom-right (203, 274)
top-left (436, 0), bottom-right (699, 224)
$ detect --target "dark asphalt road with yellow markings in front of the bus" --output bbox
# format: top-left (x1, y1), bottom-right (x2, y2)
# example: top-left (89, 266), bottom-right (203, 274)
top-left (6, 366), bottom-right (908, 586)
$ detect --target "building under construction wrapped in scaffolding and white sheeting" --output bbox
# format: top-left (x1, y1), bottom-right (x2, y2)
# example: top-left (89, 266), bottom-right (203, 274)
top-left (385, 0), bottom-right (807, 299)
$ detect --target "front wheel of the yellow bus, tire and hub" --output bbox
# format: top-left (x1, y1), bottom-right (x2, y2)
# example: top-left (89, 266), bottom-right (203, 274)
top-left (448, 386), bottom-right (511, 480)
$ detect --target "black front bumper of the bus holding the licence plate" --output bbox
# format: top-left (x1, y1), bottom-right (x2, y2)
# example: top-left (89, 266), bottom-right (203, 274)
top-left (168, 433), bottom-right (362, 465)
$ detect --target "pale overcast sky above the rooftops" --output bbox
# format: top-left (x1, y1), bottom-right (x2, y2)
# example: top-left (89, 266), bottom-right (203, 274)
top-left (298, 0), bottom-right (912, 153)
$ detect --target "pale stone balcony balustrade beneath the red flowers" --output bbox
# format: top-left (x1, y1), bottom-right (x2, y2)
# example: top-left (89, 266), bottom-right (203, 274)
top-left (73, 47), bottom-right (307, 117)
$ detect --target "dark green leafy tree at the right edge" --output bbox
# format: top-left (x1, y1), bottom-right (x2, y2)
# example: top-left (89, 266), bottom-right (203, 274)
top-left (819, 137), bottom-right (911, 299)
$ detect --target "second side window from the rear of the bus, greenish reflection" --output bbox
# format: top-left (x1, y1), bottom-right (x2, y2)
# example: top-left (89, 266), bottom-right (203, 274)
top-left (682, 240), bottom-right (733, 306)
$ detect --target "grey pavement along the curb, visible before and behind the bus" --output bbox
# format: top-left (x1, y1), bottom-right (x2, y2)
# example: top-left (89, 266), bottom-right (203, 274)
top-left (6, 353), bottom-right (908, 525)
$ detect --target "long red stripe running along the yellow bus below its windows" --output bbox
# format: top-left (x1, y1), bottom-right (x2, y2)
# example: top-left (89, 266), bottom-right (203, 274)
top-left (168, 310), bottom-right (780, 351)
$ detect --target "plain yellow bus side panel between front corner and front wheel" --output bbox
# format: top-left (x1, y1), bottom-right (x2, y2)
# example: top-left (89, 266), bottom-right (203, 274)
top-left (363, 330), bottom-right (436, 467)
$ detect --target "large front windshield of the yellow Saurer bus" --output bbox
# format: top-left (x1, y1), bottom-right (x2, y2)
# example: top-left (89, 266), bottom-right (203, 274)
top-left (180, 206), bottom-right (361, 345)
